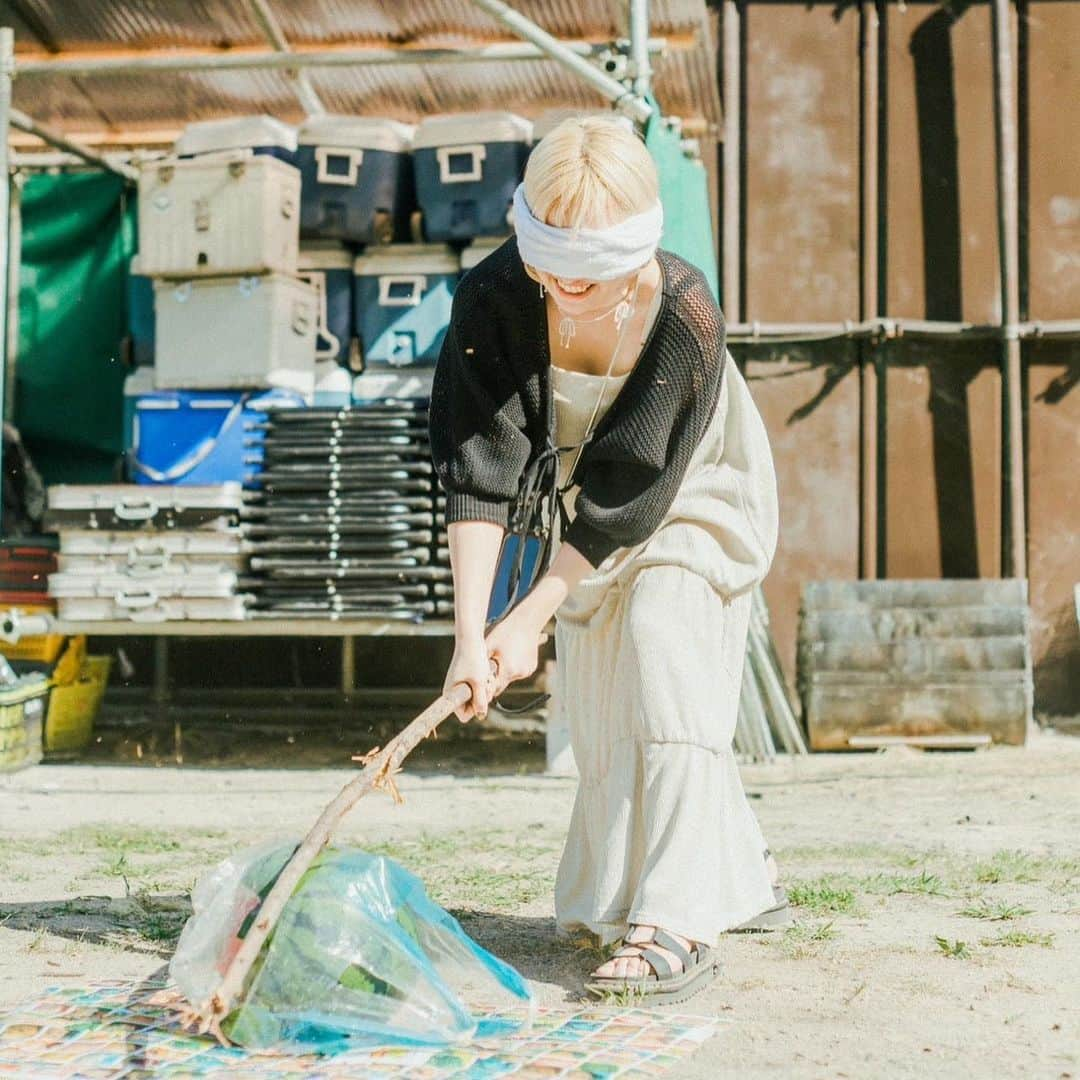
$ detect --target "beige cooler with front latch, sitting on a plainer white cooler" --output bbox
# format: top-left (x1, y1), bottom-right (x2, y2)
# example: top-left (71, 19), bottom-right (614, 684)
top-left (138, 150), bottom-right (300, 278)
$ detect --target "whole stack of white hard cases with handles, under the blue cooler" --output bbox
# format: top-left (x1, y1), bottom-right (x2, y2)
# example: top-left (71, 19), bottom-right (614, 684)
top-left (46, 484), bottom-right (246, 622)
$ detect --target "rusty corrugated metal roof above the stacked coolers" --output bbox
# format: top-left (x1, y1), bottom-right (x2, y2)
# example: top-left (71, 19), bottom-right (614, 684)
top-left (0, 0), bottom-right (719, 136)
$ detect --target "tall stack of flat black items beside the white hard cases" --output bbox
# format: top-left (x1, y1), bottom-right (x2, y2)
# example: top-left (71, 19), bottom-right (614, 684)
top-left (244, 397), bottom-right (453, 620)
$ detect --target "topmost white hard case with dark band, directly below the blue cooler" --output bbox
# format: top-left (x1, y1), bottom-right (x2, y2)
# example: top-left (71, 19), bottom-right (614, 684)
top-left (45, 484), bottom-right (244, 533)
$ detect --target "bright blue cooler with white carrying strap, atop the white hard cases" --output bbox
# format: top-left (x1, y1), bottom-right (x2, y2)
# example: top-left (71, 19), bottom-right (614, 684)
top-left (124, 374), bottom-right (306, 485)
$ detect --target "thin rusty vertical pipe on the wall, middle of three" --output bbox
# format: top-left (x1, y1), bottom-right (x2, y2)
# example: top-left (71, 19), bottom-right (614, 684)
top-left (859, 0), bottom-right (879, 579)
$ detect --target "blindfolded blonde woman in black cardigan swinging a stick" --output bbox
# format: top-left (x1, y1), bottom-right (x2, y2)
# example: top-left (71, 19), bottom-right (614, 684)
top-left (431, 118), bottom-right (778, 1000)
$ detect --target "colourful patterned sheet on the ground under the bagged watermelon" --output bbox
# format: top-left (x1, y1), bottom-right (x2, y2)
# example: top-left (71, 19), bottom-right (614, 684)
top-left (0, 982), bottom-right (719, 1080)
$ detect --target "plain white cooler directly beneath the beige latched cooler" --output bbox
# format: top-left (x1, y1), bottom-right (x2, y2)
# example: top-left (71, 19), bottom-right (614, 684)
top-left (153, 274), bottom-right (319, 401)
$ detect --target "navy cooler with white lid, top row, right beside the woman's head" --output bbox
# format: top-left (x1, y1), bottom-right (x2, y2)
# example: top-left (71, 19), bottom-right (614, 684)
top-left (413, 112), bottom-right (532, 241)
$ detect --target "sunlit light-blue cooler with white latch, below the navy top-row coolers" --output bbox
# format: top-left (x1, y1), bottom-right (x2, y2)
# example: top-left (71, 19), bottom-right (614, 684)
top-left (353, 244), bottom-right (461, 370)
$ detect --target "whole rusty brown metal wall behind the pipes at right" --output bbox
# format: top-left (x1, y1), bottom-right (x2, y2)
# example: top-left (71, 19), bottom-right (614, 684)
top-left (729, 0), bottom-right (1080, 713)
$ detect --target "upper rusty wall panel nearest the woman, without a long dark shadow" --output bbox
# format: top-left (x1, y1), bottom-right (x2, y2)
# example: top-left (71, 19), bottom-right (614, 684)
top-left (743, 3), bottom-right (859, 322)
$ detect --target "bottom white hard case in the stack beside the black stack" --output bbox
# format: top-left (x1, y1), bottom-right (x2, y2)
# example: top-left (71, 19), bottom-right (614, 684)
top-left (49, 570), bottom-right (246, 622)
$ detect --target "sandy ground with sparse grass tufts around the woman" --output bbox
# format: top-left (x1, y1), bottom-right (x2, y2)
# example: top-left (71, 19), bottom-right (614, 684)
top-left (0, 734), bottom-right (1080, 1080)
